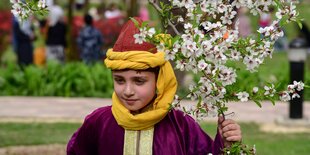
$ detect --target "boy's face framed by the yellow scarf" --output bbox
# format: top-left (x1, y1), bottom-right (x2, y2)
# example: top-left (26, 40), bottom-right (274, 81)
top-left (113, 70), bottom-right (156, 112)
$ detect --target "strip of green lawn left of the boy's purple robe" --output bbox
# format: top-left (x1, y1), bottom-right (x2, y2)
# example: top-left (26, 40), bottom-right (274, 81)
top-left (0, 123), bottom-right (81, 147)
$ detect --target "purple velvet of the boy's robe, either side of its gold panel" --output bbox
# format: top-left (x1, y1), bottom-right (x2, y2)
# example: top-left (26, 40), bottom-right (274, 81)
top-left (67, 106), bottom-right (223, 155)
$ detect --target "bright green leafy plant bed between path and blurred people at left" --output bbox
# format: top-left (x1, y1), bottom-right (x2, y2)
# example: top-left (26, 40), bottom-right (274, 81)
top-left (0, 62), bottom-right (113, 97)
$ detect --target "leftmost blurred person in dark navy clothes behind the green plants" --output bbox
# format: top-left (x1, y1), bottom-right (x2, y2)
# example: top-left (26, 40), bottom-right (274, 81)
top-left (13, 17), bottom-right (35, 66)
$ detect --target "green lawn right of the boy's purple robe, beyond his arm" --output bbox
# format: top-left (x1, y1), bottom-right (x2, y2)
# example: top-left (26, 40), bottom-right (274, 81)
top-left (201, 123), bottom-right (310, 155)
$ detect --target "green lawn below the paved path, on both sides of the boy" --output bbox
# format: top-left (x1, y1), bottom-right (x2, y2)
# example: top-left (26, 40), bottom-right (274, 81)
top-left (0, 123), bottom-right (310, 155)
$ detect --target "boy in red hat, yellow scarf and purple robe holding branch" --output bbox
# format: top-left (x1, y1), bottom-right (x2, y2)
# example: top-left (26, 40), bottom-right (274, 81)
top-left (67, 19), bottom-right (241, 155)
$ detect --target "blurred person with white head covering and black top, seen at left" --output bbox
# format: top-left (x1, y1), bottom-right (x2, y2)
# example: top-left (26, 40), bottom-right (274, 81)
top-left (46, 5), bottom-right (67, 63)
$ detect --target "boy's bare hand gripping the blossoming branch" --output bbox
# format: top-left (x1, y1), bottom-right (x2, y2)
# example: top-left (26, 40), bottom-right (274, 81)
top-left (218, 116), bottom-right (242, 147)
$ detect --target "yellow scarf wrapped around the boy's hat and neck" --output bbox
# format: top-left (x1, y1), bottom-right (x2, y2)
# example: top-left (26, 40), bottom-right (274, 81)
top-left (104, 49), bottom-right (177, 130)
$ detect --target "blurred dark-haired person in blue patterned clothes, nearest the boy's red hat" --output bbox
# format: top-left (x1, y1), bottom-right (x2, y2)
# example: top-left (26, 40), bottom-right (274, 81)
top-left (77, 14), bottom-right (103, 64)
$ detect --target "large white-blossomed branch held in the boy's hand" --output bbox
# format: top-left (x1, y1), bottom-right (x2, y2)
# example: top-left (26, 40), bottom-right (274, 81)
top-left (134, 0), bottom-right (304, 117)
